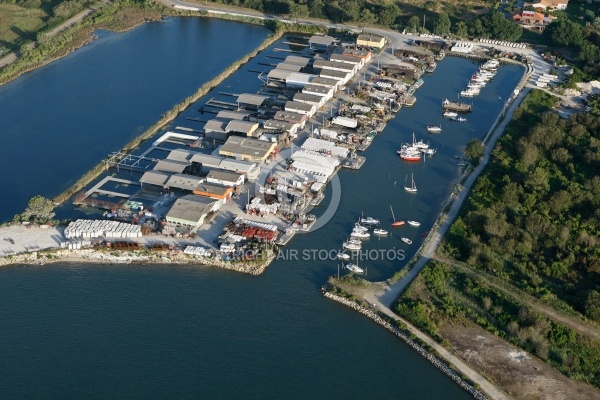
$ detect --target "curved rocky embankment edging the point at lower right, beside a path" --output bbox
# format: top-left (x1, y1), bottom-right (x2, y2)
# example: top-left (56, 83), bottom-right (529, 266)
top-left (323, 291), bottom-right (487, 400)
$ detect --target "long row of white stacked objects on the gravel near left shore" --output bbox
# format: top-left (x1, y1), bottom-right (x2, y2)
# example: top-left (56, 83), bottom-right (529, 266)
top-left (65, 219), bottom-right (142, 239)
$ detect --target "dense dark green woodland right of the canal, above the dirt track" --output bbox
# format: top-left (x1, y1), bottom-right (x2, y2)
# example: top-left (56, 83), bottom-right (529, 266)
top-left (443, 91), bottom-right (600, 322)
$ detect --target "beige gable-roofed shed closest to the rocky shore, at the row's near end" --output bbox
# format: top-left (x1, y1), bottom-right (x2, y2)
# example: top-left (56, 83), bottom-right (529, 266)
top-left (166, 194), bottom-right (221, 230)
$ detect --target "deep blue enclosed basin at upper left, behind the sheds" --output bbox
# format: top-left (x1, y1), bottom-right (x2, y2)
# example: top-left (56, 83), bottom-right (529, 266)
top-left (0, 18), bottom-right (269, 221)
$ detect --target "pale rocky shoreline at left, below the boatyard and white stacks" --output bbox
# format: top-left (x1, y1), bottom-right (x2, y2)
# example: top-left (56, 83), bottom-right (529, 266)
top-left (0, 249), bottom-right (275, 275)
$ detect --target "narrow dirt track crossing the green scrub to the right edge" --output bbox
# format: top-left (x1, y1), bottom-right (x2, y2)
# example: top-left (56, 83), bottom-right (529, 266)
top-left (435, 256), bottom-right (600, 342)
